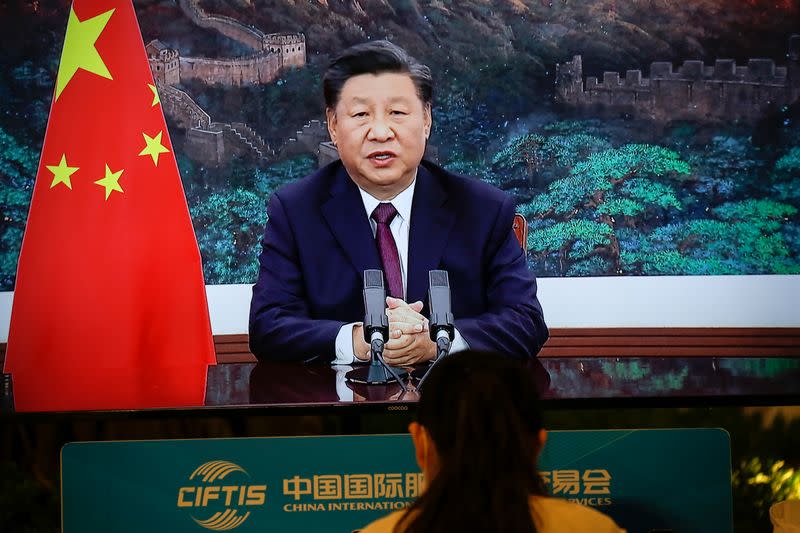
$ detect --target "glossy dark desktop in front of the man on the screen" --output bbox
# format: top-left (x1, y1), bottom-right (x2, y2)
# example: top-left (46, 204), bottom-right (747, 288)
top-left (206, 357), bottom-right (800, 407)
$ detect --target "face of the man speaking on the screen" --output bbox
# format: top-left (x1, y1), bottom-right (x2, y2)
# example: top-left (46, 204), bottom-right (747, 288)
top-left (327, 73), bottom-right (431, 200)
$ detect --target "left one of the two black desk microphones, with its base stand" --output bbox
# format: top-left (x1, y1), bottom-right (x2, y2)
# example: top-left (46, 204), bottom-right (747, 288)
top-left (345, 269), bottom-right (408, 391)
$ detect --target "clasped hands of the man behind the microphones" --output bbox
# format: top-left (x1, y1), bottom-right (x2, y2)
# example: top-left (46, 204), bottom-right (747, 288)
top-left (353, 296), bottom-right (436, 366)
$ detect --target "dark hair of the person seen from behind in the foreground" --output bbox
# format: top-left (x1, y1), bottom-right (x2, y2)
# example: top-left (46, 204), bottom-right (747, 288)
top-left (395, 350), bottom-right (545, 533)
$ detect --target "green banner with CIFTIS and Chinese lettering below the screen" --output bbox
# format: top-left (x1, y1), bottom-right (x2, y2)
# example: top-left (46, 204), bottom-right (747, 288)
top-left (61, 429), bottom-right (731, 533)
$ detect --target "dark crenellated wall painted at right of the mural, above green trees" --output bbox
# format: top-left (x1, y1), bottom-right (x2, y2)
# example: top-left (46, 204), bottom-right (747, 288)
top-left (555, 35), bottom-right (800, 122)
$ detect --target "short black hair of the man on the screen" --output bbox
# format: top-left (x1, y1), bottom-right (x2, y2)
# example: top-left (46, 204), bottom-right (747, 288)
top-left (322, 41), bottom-right (433, 109)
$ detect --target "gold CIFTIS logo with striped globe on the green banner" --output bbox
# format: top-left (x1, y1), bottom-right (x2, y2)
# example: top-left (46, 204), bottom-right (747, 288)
top-left (178, 461), bottom-right (267, 531)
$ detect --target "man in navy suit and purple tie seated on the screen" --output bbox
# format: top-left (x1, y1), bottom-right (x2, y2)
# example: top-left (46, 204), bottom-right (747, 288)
top-left (250, 41), bottom-right (548, 366)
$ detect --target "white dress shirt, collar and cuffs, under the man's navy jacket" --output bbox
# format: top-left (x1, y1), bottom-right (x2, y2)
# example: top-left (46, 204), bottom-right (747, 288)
top-left (331, 178), bottom-right (469, 365)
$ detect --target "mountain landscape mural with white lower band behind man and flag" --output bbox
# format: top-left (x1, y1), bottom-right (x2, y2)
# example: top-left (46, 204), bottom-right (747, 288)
top-left (0, 0), bottom-right (800, 412)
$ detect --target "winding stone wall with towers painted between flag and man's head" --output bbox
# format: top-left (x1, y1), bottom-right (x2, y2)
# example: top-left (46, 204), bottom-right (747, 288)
top-left (145, 0), bottom-right (328, 166)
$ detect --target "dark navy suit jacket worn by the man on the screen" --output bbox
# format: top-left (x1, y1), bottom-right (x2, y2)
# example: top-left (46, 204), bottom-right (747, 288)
top-left (250, 161), bottom-right (548, 361)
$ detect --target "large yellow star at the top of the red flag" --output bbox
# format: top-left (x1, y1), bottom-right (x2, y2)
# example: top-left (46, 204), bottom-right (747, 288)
top-left (56, 8), bottom-right (114, 100)
